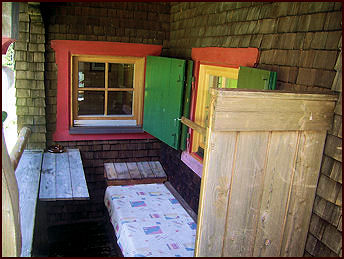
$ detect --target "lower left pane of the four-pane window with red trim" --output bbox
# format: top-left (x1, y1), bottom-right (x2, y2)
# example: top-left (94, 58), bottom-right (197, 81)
top-left (78, 91), bottom-right (105, 115)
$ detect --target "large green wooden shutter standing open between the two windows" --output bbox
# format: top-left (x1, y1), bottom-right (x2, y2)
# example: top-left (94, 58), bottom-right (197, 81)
top-left (143, 56), bottom-right (186, 149)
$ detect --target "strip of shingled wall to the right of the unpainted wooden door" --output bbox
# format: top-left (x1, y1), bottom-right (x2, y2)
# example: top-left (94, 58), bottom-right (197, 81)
top-left (306, 41), bottom-right (342, 256)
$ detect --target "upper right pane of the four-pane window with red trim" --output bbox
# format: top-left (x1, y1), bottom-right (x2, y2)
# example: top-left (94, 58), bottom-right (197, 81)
top-left (109, 63), bottom-right (134, 88)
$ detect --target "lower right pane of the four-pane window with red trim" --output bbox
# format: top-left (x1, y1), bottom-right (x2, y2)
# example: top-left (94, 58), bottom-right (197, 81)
top-left (108, 91), bottom-right (133, 115)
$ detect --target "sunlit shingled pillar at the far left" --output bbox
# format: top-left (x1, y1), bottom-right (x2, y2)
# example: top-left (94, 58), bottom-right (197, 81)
top-left (14, 3), bottom-right (46, 149)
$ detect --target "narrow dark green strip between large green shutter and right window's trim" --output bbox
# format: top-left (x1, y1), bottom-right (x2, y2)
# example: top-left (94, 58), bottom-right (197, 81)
top-left (180, 60), bottom-right (193, 151)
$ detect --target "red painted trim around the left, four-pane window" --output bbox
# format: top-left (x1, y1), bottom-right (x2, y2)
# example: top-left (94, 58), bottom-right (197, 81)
top-left (51, 40), bottom-right (162, 141)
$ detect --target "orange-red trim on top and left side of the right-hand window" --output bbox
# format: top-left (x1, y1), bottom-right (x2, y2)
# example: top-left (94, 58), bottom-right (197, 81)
top-left (187, 47), bottom-right (259, 152)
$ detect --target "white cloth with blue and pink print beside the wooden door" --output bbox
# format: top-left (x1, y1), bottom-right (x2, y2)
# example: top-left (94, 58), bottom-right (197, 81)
top-left (104, 184), bottom-right (196, 257)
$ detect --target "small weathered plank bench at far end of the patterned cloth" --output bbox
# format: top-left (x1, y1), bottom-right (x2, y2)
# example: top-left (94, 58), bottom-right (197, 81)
top-left (104, 161), bottom-right (167, 186)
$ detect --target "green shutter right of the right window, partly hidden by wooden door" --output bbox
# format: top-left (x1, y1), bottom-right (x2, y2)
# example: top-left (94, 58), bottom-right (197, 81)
top-left (238, 67), bottom-right (276, 90)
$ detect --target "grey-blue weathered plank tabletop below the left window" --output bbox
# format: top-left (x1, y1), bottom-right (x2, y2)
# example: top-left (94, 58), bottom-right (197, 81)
top-left (39, 149), bottom-right (90, 201)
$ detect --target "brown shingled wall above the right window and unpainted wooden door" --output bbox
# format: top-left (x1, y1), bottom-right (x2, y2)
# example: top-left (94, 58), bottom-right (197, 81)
top-left (168, 2), bottom-right (342, 91)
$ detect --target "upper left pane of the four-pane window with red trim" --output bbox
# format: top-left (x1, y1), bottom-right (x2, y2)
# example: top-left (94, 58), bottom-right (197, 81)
top-left (78, 62), bottom-right (105, 88)
